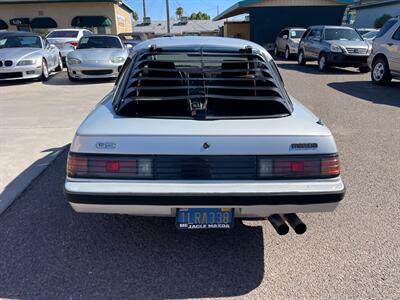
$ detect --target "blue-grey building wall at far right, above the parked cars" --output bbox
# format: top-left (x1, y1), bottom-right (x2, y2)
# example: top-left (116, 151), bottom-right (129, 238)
top-left (354, 3), bottom-right (400, 28)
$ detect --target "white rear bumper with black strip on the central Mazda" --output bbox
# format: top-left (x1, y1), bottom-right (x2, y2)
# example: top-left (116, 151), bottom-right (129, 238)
top-left (65, 178), bottom-right (345, 217)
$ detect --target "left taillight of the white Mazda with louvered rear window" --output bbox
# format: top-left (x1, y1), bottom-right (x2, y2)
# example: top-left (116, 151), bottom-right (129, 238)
top-left (67, 153), bottom-right (153, 179)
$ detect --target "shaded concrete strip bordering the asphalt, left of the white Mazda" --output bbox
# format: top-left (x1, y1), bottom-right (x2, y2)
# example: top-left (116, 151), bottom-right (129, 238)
top-left (0, 145), bottom-right (69, 215)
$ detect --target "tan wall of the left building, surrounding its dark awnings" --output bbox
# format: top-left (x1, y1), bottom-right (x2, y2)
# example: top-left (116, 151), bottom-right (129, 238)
top-left (0, 2), bottom-right (132, 34)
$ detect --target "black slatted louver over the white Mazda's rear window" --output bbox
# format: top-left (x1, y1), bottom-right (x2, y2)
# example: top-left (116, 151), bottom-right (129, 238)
top-left (117, 47), bottom-right (290, 119)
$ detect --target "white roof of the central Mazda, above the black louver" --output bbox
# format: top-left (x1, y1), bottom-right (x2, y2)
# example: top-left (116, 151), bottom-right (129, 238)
top-left (135, 36), bottom-right (269, 57)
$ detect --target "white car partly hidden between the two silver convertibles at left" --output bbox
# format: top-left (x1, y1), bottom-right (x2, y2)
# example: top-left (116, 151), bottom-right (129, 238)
top-left (46, 29), bottom-right (92, 65)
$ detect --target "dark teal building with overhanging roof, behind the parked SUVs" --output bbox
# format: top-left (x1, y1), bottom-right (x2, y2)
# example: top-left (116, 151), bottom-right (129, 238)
top-left (213, 0), bottom-right (353, 50)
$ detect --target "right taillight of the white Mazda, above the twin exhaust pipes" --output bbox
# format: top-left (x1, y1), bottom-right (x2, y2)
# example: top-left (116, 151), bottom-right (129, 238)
top-left (258, 155), bottom-right (340, 179)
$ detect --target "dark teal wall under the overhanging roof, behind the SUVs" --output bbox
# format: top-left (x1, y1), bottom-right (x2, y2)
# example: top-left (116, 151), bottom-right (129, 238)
top-left (250, 5), bottom-right (346, 50)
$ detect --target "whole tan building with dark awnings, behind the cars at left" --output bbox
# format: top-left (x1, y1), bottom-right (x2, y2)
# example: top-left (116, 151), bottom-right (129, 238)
top-left (0, 0), bottom-right (133, 34)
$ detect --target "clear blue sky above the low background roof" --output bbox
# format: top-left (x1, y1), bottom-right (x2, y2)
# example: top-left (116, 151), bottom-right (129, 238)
top-left (128, 0), bottom-right (239, 20)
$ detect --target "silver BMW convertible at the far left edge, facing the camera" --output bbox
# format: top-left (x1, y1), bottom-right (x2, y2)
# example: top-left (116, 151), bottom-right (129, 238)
top-left (0, 32), bottom-right (62, 81)
